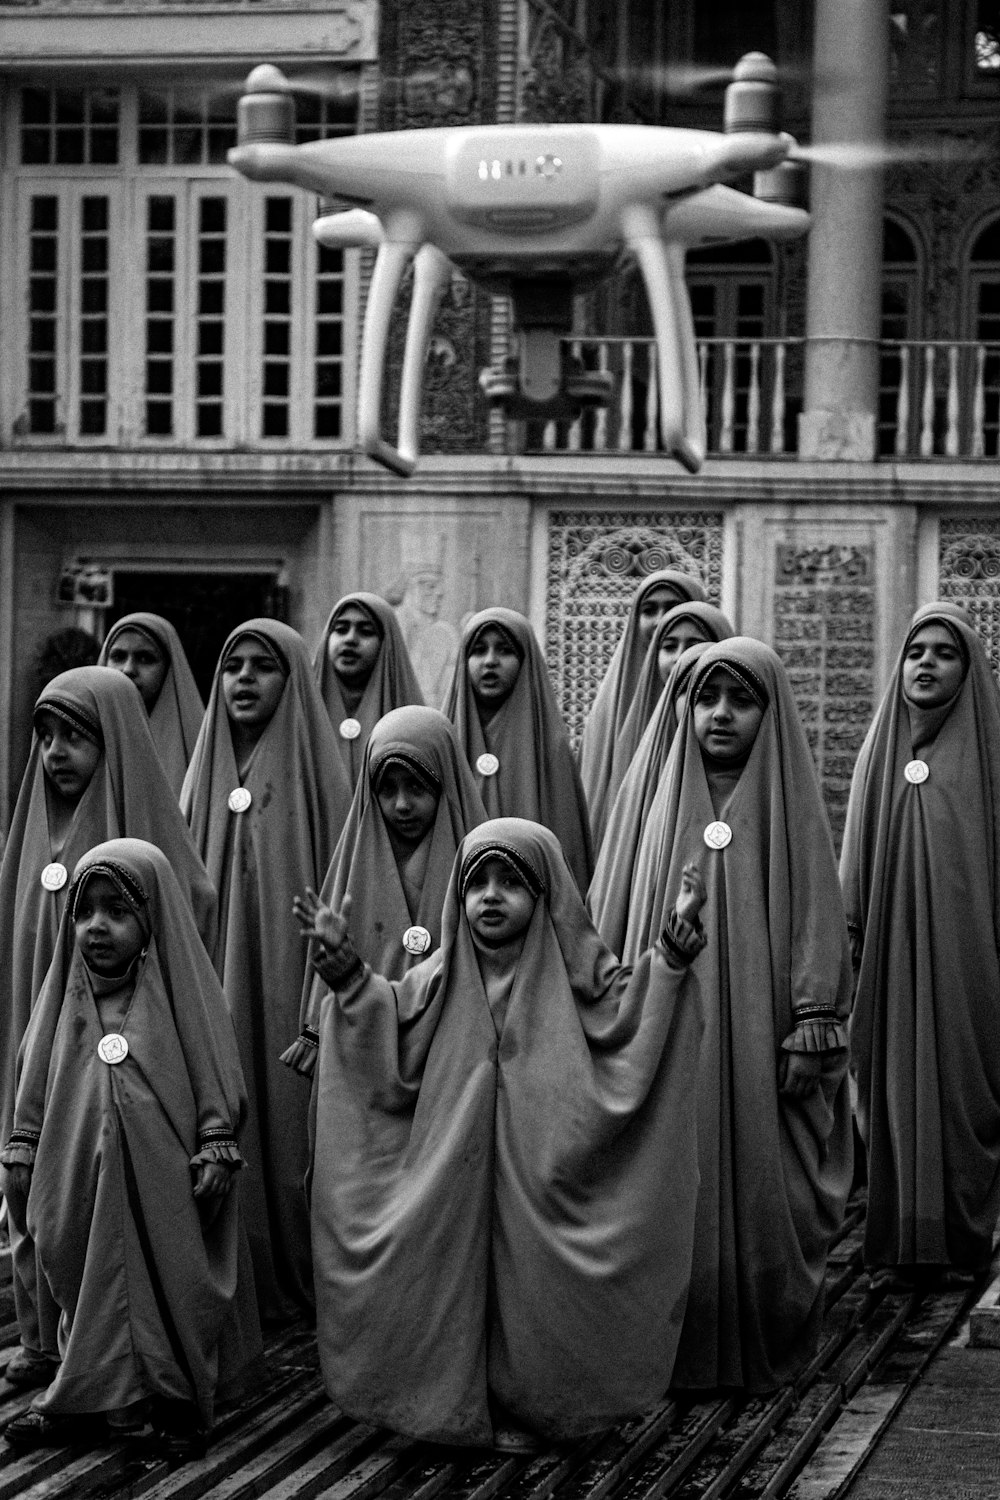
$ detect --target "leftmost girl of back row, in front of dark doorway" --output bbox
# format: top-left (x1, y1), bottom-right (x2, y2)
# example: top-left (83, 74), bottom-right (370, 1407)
top-left (99, 614), bottom-right (205, 797)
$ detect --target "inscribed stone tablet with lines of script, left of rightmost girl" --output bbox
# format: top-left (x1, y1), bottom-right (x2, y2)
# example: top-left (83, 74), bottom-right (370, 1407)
top-left (774, 543), bottom-right (876, 846)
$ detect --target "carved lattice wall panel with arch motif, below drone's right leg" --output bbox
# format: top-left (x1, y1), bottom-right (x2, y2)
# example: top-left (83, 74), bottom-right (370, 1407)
top-left (546, 510), bottom-right (723, 744)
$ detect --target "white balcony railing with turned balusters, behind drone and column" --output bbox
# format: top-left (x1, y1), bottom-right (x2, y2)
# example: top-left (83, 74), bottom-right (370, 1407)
top-left (511, 339), bottom-right (1000, 459)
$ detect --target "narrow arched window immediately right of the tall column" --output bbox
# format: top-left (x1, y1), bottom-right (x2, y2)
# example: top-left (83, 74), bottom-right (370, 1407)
top-left (879, 218), bottom-right (922, 456)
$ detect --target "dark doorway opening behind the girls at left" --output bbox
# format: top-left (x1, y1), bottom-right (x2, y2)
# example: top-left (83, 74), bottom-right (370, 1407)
top-left (105, 569), bottom-right (286, 701)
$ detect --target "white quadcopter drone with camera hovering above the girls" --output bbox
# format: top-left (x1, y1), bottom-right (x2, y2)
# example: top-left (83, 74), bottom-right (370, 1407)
top-left (229, 53), bottom-right (810, 474)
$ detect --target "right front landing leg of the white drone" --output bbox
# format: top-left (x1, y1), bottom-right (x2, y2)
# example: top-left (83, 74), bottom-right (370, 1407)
top-left (624, 207), bottom-right (702, 474)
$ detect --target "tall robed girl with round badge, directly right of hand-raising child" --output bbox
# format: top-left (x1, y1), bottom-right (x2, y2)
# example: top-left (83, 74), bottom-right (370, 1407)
top-left (625, 636), bottom-right (852, 1392)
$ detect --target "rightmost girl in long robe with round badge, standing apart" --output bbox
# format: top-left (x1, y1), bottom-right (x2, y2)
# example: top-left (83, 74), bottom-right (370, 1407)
top-left (841, 602), bottom-right (1000, 1281)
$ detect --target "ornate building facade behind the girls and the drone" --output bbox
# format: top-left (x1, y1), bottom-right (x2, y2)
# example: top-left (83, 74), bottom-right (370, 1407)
top-left (0, 0), bottom-right (1000, 846)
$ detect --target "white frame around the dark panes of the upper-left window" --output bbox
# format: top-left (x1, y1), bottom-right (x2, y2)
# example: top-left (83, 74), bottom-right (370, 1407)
top-left (0, 80), bottom-right (361, 452)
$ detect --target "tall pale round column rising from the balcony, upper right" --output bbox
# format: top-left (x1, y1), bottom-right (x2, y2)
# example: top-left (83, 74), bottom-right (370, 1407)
top-left (799, 0), bottom-right (889, 462)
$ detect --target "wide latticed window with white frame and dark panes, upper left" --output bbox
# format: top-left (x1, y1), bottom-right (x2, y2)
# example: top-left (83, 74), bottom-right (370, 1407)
top-left (4, 86), bottom-right (355, 447)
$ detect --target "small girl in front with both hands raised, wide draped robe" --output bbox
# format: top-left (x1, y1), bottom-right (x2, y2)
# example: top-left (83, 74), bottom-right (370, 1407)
top-left (304, 818), bottom-right (705, 1445)
